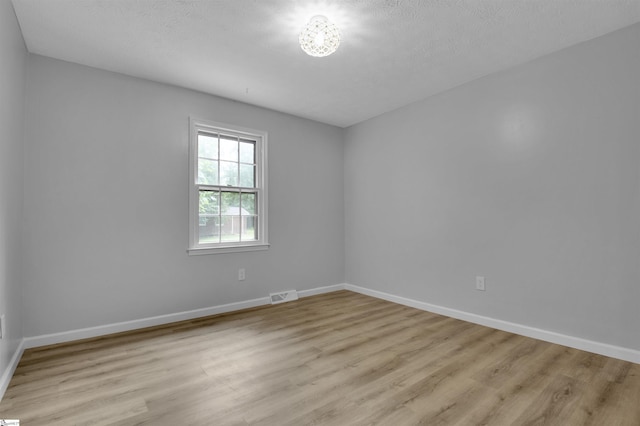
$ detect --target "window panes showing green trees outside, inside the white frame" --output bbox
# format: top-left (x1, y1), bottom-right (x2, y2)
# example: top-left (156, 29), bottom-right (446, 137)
top-left (197, 133), bottom-right (258, 243)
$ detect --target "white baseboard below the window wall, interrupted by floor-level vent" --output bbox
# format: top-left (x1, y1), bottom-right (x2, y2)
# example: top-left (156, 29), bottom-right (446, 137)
top-left (24, 284), bottom-right (345, 349)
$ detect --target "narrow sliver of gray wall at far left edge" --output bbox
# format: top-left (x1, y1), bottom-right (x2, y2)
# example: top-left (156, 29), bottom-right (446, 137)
top-left (0, 0), bottom-right (27, 375)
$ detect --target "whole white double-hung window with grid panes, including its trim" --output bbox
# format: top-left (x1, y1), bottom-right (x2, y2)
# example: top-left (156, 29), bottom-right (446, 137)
top-left (189, 118), bottom-right (269, 254)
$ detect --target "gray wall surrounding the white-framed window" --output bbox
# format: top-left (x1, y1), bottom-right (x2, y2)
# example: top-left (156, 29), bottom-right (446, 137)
top-left (24, 55), bottom-right (344, 336)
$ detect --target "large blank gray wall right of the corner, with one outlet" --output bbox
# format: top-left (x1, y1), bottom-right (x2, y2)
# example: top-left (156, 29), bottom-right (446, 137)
top-left (345, 24), bottom-right (640, 349)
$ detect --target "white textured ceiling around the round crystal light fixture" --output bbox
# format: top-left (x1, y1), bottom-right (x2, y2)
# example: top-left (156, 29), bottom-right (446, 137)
top-left (12, 0), bottom-right (640, 127)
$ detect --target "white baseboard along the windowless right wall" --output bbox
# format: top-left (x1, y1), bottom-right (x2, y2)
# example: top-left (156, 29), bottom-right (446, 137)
top-left (344, 284), bottom-right (640, 364)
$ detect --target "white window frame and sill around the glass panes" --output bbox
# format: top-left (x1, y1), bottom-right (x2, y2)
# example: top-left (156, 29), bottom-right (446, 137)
top-left (187, 117), bottom-right (269, 255)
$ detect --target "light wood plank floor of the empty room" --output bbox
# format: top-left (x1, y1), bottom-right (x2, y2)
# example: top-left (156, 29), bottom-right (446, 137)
top-left (0, 291), bottom-right (640, 426)
